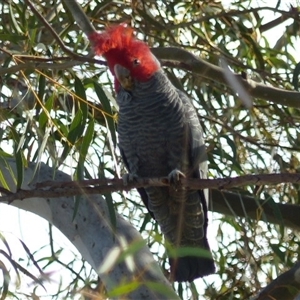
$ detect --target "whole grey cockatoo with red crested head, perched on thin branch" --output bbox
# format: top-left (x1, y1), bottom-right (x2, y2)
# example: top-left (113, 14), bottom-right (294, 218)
top-left (89, 24), bottom-right (215, 281)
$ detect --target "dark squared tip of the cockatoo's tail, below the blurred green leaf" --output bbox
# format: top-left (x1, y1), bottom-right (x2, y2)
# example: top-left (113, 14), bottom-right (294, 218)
top-left (169, 245), bottom-right (215, 282)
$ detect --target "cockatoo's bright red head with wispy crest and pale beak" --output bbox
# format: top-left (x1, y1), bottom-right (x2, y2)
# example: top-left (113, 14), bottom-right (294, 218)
top-left (89, 23), bottom-right (160, 90)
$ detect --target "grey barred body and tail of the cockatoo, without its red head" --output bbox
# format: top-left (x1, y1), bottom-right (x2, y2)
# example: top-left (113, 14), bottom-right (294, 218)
top-left (117, 70), bottom-right (215, 281)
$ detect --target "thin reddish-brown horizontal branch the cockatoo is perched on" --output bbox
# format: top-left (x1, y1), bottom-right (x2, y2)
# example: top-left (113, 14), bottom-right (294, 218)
top-left (0, 173), bottom-right (300, 203)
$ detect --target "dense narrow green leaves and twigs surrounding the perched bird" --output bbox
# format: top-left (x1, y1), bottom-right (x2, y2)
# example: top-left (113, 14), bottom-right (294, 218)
top-left (0, 0), bottom-right (300, 299)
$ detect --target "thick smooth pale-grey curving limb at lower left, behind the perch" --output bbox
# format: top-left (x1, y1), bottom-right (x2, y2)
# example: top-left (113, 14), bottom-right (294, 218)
top-left (0, 159), bottom-right (179, 300)
